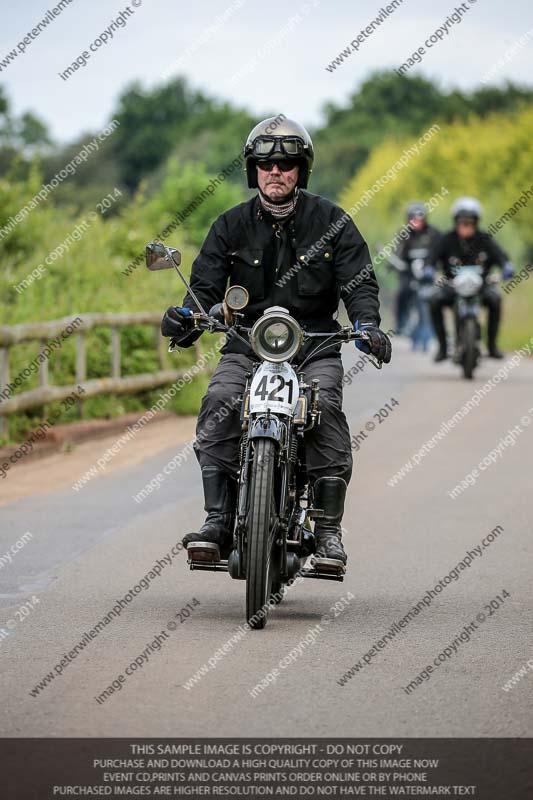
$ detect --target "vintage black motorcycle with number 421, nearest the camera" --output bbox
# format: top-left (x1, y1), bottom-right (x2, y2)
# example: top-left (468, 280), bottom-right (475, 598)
top-left (146, 243), bottom-right (382, 629)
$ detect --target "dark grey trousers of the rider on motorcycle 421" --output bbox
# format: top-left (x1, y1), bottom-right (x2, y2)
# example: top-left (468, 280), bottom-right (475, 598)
top-left (194, 353), bottom-right (352, 483)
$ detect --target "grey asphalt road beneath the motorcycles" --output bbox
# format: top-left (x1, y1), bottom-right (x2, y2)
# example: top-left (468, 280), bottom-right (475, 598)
top-left (0, 341), bottom-right (533, 737)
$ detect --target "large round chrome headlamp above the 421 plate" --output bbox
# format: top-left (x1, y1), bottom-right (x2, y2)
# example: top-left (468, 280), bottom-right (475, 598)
top-left (250, 309), bottom-right (303, 363)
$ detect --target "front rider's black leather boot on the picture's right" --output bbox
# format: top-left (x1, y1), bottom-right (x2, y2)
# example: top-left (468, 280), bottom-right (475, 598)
top-left (314, 478), bottom-right (347, 564)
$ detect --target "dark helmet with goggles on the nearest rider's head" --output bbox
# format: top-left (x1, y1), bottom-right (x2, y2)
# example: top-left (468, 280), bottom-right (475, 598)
top-left (244, 114), bottom-right (315, 189)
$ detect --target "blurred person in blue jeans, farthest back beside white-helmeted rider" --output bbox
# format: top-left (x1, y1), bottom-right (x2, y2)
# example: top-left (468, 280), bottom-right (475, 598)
top-left (390, 200), bottom-right (442, 349)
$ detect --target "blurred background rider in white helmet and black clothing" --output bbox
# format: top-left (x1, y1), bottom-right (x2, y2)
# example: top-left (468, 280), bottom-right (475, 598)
top-left (426, 197), bottom-right (514, 362)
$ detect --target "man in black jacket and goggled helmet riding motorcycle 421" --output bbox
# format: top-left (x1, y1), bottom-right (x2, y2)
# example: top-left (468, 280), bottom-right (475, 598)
top-left (161, 115), bottom-right (391, 563)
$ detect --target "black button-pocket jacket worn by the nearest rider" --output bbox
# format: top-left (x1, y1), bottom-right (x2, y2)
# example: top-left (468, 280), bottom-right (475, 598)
top-left (180, 190), bottom-right (380, 360)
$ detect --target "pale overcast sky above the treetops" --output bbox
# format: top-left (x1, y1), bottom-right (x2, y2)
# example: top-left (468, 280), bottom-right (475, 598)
top-left (0, 0), bottom-right (533, 142)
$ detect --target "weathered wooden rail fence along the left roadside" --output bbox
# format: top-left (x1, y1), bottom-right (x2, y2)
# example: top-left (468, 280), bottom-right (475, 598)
top-left (0, 311), bottom-right (200, 435)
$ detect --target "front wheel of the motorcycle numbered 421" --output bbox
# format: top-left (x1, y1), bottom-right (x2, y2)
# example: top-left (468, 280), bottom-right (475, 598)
top-left (246, 439), bottom-right (277, 630)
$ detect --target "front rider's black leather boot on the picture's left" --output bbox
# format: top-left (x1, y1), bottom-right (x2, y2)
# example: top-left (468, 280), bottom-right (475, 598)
top-left (182, 467), bottom-right (237, 561)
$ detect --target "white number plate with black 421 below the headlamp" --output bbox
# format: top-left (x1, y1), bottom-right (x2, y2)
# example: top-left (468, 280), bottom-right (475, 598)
top-left (250, 361), bottom-right (298, 415)
